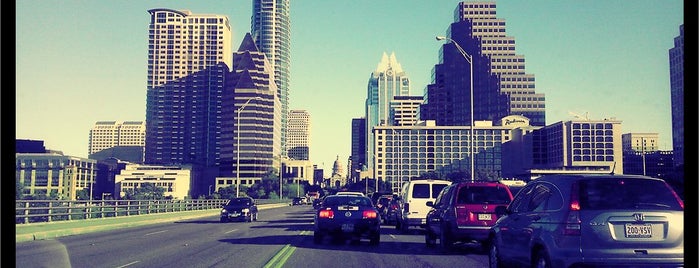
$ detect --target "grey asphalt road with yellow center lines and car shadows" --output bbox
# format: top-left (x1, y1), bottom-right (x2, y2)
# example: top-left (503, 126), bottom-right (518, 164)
top-left (15, 206), bottom-right (488, 268)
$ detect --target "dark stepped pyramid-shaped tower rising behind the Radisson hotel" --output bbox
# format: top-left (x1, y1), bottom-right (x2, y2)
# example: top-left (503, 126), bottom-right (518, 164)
top-left (420, 1), bottom-right (546, 126)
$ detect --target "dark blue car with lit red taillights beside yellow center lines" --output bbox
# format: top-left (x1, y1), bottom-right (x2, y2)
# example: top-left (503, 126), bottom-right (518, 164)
top-left (313, 195), bottom-right (381, 245)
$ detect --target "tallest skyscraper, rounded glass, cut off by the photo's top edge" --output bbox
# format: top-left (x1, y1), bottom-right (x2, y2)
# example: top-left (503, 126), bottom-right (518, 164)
top-left (250, 0), bottom-right (291, 159)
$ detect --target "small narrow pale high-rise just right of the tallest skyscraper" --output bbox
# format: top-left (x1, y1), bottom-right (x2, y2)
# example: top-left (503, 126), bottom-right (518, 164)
top-left (286, 110), bottom-right (311, 160)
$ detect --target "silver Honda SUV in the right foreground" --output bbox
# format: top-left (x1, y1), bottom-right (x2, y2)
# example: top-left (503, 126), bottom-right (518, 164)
top-left (488, 174), bottom-right (684, 267)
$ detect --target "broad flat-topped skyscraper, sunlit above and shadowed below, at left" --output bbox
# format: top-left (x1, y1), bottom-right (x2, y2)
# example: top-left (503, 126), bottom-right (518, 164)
top-left (145, 8), bottom-right (232, 167)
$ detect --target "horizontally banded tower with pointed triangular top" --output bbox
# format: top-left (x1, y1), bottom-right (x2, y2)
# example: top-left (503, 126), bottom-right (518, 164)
top-left (217, 33), bottom-right (281, 186)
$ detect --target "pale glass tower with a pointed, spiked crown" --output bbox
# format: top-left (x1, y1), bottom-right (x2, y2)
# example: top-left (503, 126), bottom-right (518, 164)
top-left (365, 52), bottom-right (410, 173)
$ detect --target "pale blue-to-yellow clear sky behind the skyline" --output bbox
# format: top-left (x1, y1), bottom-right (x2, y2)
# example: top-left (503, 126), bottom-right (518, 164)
top-left (16, 0), bottom-right (684, 175)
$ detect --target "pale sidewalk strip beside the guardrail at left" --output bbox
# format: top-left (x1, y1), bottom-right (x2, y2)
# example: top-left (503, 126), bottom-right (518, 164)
top-left (15, 203), bottom-right (289, 243)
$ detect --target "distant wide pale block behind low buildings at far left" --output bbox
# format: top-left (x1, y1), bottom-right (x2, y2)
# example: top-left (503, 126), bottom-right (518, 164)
top-left (87, 121), bottom-right (146, 155)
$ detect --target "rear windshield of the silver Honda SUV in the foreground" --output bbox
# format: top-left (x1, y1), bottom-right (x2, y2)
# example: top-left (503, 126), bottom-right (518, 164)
top-left (579, 178), bottom-right (682, 210)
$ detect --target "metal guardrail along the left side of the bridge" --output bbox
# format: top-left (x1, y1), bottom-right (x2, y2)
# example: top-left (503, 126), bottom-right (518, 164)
top-left (15, 199), bottom-right (289, 224)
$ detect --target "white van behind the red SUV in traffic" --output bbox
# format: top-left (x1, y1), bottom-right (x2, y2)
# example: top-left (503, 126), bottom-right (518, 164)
top-left (396, 179), bottom-right (451, 231)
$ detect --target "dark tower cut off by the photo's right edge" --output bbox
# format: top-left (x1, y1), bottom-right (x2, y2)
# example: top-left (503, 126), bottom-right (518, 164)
top-left (669, 24), bottom-right (684, 167)
